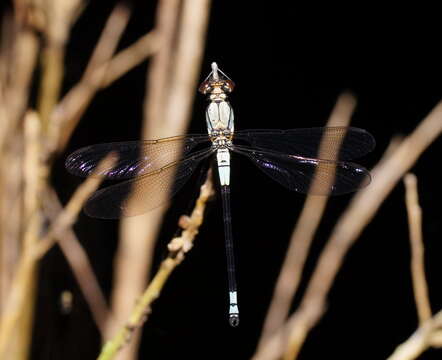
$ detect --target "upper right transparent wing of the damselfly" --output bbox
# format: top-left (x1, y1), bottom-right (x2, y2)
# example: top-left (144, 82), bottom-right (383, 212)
top-left (234, 127), bottom-right (376, 161)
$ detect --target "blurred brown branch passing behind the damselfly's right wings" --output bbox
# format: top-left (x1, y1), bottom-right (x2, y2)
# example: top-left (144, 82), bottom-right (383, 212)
top-left (258, 94), bottom-right (356, 348)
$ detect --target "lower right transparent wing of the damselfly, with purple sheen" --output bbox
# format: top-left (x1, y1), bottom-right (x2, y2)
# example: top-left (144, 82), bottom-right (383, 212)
top-left (232, 146), bottom-right (371, 195)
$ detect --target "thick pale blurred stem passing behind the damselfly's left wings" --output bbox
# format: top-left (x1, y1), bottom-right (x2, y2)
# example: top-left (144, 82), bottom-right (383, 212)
top-left (109, 0), bottom-right (210, 359)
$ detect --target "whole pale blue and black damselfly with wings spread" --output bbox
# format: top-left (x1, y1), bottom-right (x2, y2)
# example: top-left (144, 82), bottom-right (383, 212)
top-left (65, 62), bottom-right (375, 327)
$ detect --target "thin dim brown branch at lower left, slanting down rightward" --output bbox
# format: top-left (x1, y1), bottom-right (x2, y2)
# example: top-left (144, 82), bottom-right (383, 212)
top-left (43, 188), bottom-right (110, 338)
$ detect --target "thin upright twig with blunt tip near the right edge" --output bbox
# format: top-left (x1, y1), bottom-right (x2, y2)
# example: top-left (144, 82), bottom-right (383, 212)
top-left (404, 173), bottom-right (431, 325)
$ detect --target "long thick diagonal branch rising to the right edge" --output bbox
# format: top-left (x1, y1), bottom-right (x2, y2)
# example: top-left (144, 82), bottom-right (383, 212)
top-left (253, 103), bottom-right (442, 360)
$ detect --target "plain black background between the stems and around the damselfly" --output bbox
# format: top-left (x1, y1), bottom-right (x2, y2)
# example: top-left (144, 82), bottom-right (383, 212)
top-left (13, 1), bottom-right (442, 359)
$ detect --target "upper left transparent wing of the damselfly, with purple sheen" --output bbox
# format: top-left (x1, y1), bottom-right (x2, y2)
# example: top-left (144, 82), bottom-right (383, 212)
top-left (65, 135), bottom-right (209, 180)
